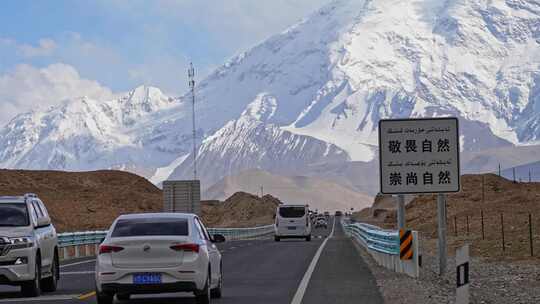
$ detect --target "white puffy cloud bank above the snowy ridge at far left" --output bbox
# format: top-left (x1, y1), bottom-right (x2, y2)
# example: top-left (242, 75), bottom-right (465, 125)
top-left (0, 63), bottom-right (113, 125)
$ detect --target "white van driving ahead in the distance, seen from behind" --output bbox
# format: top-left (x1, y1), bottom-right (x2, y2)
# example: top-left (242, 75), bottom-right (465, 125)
top-left (274, 205), bottom-right (311, 242)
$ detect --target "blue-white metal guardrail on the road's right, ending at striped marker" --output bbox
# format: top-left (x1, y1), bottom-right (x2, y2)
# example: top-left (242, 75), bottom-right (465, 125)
top-left (342, 221), bottom-right (399, 255)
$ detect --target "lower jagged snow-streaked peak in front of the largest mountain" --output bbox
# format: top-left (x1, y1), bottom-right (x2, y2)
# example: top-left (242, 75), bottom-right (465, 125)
top-left (170, 94), bottom-right (350, 187)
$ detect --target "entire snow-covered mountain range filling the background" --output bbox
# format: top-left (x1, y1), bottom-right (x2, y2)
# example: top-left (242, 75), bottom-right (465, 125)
top-left (0, 0), bottom-right (540, 190)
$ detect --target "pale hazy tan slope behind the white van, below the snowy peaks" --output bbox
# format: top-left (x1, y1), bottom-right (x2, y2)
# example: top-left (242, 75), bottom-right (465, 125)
top-left (206, 170), bottom-right (372, 211)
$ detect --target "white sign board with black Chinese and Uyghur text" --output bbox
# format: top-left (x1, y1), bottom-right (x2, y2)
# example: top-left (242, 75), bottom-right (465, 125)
top-left (379, 117), bottom-right (460, 194)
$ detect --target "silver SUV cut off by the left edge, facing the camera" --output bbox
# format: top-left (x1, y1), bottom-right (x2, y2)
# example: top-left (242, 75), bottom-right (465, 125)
top-left (0, 193), bottom-right (60, 297)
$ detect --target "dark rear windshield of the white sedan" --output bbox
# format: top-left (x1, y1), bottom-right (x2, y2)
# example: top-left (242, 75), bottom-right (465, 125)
top-left (112, 218), bottom-right (189, 237)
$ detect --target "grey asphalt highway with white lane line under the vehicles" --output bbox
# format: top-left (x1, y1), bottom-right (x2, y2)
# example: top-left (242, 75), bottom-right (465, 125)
top-left (0, 220), bottom-right (383, 304)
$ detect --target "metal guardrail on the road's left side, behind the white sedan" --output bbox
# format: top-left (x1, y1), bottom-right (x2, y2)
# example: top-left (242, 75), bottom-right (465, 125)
top-left (58, 225), bottom-right (274, 248)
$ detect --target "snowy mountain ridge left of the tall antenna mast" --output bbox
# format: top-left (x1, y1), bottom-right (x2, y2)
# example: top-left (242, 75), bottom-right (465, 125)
top-left (0, 87), bottom-right (189, 175)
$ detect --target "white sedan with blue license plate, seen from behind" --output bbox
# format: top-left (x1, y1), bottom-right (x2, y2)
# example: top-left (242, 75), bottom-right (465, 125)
top-left (96, 213), bottom-right (225, 304)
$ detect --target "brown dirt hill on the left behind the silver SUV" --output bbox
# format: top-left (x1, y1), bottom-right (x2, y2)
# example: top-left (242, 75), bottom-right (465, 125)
top-left (0, 170), bottom-right (163, 231)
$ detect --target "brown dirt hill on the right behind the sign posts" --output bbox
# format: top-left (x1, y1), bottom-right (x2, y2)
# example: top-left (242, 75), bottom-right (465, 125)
top-left (356, 174), bottom-right (540, 258)
